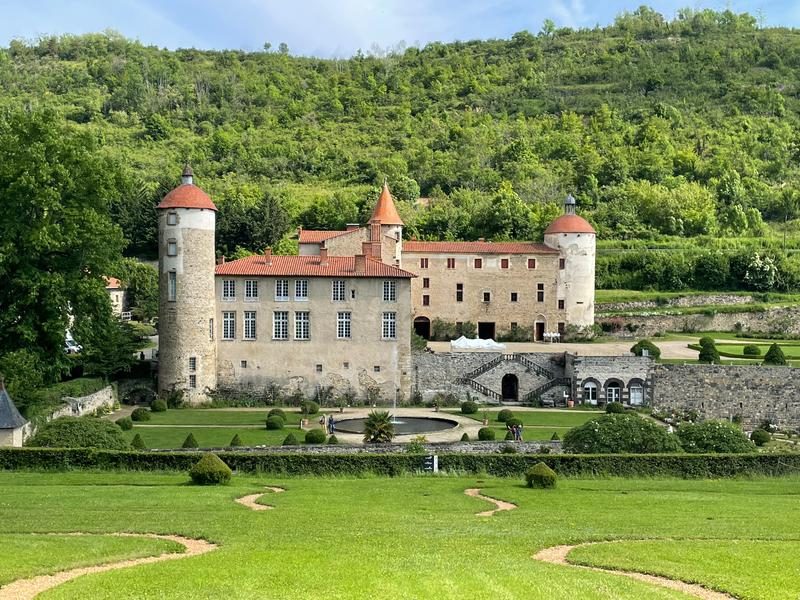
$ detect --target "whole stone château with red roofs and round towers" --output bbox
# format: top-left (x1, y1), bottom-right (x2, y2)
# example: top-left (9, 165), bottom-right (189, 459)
top-left (158, 167), bottom-right (595, 403)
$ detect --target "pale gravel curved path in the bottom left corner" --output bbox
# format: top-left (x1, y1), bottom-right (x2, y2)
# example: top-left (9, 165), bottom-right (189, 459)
top-left (0, 533), bottom-right (217, 600)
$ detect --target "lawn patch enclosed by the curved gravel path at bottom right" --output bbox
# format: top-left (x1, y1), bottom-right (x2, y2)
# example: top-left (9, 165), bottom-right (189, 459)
top-left (568, 540), bottom-right (800, 600)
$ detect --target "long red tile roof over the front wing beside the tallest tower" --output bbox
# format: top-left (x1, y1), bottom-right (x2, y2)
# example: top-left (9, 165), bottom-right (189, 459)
top-left (215, 255), bottom-right (416, 278)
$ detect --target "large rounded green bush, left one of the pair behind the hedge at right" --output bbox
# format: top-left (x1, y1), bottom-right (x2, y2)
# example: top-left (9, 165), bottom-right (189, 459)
top-left (562, 413), bottom-right (681, 454)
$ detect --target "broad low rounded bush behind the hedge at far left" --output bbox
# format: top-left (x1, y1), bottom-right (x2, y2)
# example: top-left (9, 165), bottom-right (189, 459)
top-left (25, 417), bottom-right (128, 450)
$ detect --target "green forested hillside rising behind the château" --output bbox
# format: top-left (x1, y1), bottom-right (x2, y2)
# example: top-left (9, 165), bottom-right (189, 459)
top-left (0, 8), bottom-right (800, 266)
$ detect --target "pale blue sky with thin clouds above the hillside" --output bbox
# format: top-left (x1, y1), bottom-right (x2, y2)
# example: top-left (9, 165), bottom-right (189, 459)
top-left (0, 0), bottom-right (800, 58)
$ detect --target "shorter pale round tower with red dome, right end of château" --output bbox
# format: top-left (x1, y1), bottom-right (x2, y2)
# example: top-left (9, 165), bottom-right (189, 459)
top-left (544, 194), bottom-right (597, 327)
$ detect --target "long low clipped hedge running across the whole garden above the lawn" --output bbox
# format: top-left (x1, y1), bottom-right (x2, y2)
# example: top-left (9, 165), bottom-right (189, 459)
top-left (0, 448), bottom-right (800, 478)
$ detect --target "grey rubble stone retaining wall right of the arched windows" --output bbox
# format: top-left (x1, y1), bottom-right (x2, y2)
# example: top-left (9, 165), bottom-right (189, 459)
top-left (652, 365), bottom-right (800, 429)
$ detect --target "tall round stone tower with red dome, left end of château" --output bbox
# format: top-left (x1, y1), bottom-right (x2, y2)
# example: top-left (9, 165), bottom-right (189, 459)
top-left (157, 165), bottom-right (217, 404)
